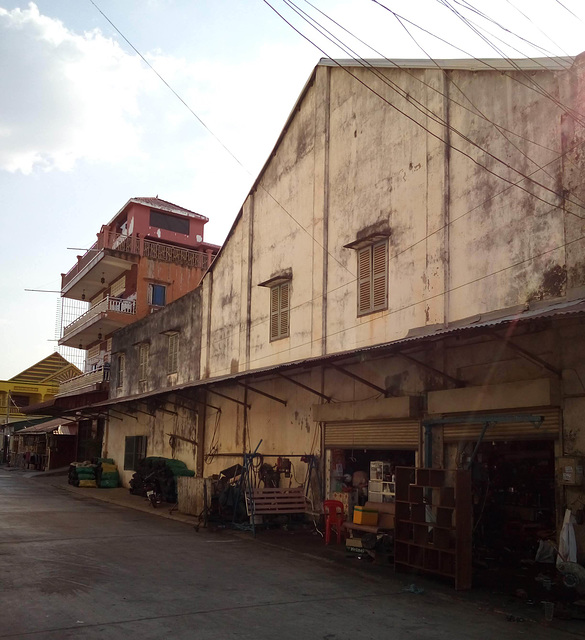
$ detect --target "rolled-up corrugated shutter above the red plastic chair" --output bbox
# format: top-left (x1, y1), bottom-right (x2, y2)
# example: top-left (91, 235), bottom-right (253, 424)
top-left (325, 420), bottom-right (420, 449)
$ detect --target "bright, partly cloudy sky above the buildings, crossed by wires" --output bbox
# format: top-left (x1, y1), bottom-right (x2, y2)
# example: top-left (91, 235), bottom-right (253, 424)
top-left (0, 0), bottom-right (585, 379)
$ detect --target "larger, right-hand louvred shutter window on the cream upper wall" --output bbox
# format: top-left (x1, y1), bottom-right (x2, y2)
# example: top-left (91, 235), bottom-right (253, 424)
top-left (357, 240), bottom-right (388, 316)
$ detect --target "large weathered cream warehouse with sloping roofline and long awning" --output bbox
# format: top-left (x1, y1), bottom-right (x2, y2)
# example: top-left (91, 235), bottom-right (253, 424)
top-left (73, 55), bottom-right (585, 568)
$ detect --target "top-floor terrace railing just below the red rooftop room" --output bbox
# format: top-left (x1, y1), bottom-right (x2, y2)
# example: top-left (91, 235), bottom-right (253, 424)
top-left (61, 231), bottom-right (212, 288)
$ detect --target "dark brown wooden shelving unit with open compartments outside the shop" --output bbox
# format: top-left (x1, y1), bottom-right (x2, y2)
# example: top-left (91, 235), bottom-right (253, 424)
top-left (394, 467), bottom-right (473, 589)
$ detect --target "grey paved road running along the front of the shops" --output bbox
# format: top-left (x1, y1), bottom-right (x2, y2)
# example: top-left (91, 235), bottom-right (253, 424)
top-left (0, 470), bottom-right (578, 640)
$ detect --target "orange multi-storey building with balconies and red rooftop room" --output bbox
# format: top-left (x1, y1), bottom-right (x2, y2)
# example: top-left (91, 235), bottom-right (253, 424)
top-left (58, 197), bottom-right (219, 396)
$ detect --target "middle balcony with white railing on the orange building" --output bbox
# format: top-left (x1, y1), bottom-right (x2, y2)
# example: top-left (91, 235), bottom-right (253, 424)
top-left (59, 296), bottom-right (136, 349)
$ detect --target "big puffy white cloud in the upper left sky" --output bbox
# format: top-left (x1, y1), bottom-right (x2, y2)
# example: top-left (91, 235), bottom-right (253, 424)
top-left (0, 3), bottom-right (154, 174)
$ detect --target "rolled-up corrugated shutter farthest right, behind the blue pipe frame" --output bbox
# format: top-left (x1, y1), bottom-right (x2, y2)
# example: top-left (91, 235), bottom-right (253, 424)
top-left (443, 407), bottom-right (561, 442)
